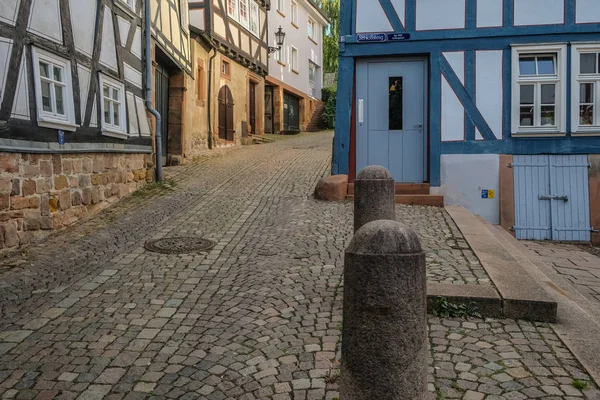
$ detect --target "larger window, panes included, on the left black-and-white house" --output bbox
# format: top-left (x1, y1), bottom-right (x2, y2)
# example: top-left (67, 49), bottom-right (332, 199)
top-left (32, 47), bottom-right (77, 131)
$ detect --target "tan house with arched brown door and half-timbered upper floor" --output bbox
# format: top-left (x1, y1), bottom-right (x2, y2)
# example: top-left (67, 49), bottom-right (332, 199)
top-left (187, 0), bottom-right (270, 151)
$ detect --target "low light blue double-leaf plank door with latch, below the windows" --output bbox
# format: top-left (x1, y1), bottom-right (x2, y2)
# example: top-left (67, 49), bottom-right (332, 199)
top-left (512, 155), bottom-right (592, 241)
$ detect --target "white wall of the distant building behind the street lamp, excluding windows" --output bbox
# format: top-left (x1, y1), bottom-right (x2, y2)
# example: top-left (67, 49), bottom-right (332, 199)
top-left (269, 0), bottom-right (326, 100)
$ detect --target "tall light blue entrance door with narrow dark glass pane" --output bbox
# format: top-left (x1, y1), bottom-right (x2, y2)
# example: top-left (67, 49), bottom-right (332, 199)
top-left (356, 59), bottom-right (427, 183)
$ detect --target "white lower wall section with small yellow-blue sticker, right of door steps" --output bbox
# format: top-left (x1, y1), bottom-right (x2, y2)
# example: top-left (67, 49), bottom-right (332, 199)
top-left (431, 154), bottom-right (500, 224)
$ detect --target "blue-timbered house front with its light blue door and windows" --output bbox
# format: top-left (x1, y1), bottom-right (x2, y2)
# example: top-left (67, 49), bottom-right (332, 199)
top-left (332, 0), bottom-right (600, 240)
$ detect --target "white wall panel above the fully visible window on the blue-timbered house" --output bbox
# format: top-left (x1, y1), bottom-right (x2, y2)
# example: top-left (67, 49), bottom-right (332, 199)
top-left (514, 0), bottom-right (564, 26)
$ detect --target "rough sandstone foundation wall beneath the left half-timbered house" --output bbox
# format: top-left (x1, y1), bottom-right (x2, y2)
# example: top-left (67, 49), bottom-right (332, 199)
top-left (0, 153), bottom-right (153, 251)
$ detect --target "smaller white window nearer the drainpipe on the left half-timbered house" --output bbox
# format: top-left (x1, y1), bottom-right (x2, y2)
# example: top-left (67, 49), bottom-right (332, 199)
top-left (100, 74), bottom-right (127, 136)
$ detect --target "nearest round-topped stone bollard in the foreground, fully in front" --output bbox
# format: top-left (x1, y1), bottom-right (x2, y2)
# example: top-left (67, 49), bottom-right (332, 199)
top-left (340, 220), bottom-right (428, 400)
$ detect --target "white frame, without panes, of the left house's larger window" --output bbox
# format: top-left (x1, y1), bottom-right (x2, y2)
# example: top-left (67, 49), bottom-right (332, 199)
top-left (31, 47), bottom-right (78, 132)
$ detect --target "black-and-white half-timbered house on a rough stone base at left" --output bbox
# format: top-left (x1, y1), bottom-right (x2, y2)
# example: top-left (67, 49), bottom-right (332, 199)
top-left (0, 0), bottom-right (152, 249)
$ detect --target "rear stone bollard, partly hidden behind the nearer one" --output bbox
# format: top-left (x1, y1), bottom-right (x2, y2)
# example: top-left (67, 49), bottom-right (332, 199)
top-left (354, 165), bottom-right (396, 232)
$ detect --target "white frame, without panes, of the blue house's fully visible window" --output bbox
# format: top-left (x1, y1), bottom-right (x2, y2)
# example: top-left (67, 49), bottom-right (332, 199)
top-left (511, 43), bottom-right (567, 137)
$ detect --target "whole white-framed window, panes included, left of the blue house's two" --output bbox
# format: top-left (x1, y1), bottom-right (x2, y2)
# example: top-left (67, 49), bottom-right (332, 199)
top-left (512, 45), bottom-right (566, 134)
